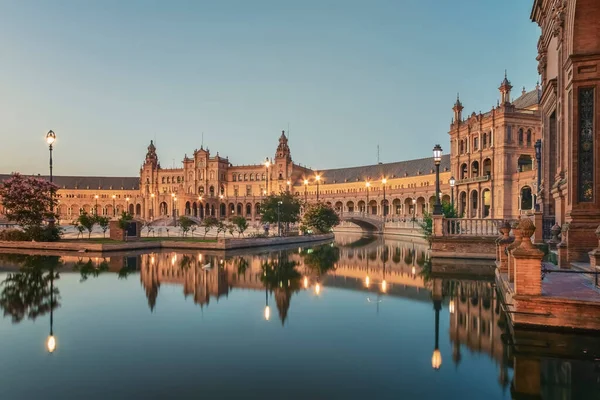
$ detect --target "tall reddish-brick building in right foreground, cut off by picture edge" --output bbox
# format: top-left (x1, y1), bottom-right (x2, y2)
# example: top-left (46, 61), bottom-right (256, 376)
top-left (531, 0), bottom-right (600, 262)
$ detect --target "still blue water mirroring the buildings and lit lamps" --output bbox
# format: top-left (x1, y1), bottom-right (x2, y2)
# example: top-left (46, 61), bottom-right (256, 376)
top-left (0, 235), bottom-right (600, 399)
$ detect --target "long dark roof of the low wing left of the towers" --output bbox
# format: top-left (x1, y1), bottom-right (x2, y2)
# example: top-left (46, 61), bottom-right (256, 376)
top-left (0, 174), bottom-right (140, 190)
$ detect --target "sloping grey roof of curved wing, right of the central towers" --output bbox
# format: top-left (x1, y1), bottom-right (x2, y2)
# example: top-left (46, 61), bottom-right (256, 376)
top-left (319, 154), bottom-right (450, 183)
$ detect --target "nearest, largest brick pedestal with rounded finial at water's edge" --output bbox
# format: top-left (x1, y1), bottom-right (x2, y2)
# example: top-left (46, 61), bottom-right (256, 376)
top-left (511, 218), bottom-right (544, 296)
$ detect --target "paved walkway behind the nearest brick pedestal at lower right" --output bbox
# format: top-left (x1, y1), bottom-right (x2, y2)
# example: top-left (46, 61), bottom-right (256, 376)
top-left (542, 263), bottom-right (600, 303)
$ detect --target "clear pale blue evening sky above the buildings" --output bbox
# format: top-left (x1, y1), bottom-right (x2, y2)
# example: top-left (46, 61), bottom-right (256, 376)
top-left (0, 0), bottom-right (539, 176)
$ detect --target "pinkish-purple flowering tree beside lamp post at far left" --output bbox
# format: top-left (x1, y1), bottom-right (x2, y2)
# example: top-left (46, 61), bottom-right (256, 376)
top-left (0, 173), bottom-right (60, 241)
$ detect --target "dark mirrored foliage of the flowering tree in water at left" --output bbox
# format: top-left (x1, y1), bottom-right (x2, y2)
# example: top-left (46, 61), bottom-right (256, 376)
top-left (0, 255), bottom-right (62, 323)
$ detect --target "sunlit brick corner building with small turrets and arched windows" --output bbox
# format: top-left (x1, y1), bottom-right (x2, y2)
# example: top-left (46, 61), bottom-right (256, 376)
top-left (448, 74), bottom-right (541, 219)
